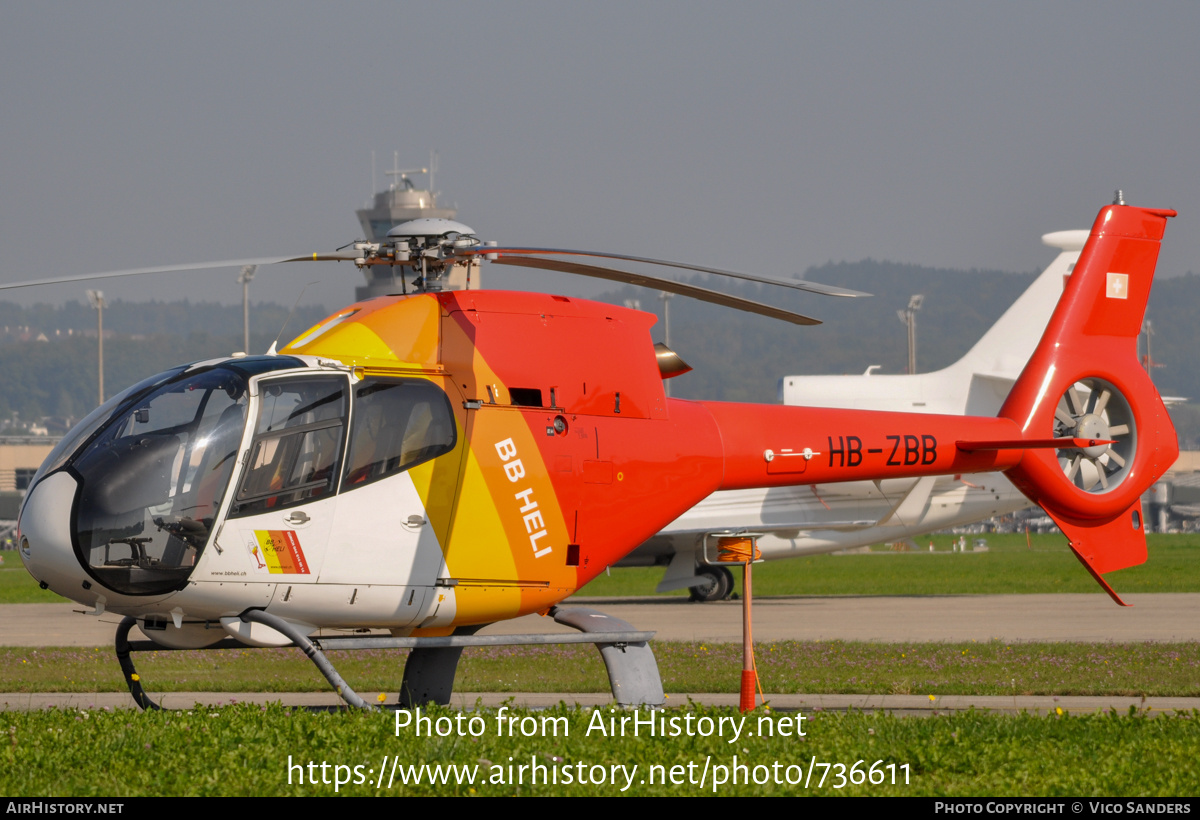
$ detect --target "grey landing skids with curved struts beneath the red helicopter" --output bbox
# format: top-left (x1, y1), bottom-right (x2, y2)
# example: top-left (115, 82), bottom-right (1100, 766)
top-left (116, 606), bottom-right (666, 710)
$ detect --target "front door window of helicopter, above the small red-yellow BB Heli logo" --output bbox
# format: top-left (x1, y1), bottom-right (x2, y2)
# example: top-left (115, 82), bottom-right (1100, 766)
top-left (230, 377), bottom-right (348, 517)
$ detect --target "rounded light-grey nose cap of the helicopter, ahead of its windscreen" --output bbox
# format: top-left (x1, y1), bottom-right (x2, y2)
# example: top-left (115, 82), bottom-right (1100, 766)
top-left (18, 472), bottom-right (92, 600)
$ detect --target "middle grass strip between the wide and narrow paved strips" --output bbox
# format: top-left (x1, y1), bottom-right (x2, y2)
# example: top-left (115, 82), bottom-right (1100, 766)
top-left (0, 641), bottom-right (1200, 698)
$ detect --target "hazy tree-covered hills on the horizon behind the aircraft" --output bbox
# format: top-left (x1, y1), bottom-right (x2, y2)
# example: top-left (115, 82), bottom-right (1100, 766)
top-left (0, 259), bottom-right (1200, 447)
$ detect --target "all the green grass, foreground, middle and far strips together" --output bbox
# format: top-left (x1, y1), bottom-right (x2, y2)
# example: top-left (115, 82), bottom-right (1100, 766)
top-left (0, 535), bottom-right (1200, 797)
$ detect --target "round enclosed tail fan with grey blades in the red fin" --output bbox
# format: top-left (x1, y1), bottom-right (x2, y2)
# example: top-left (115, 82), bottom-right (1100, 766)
top-left (1055, 378), bottom-right (1138, 493)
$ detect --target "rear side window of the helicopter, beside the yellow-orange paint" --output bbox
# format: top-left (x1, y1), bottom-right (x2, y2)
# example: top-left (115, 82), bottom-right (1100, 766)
top-left (342, 378), bottom-right (457, 492)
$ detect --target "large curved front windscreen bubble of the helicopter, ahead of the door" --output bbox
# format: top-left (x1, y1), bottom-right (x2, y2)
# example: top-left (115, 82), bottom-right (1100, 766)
top-left (59, 357), bottom-right (305, 595)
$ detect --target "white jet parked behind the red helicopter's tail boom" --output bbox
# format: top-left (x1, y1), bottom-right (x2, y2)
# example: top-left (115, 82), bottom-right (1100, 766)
top-left (617, 231), bottom-right (1088, 600)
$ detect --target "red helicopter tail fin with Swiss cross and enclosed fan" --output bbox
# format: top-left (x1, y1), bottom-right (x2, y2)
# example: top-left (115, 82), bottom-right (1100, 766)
top-left (1000, 205), bottom-right (1178, 600)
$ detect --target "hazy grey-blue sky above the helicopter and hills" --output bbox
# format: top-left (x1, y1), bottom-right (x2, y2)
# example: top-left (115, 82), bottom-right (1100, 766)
top-left (0, 0), bottom-right (1200, 309)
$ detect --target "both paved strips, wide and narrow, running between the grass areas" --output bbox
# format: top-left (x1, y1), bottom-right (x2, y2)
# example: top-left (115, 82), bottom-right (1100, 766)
top-left (0, 593), bottom-right (1200, 714)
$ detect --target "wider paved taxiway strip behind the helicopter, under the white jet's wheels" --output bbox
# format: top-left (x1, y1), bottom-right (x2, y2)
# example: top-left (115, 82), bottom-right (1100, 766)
top-left (0, 593), bottom-right (1200, 646)
